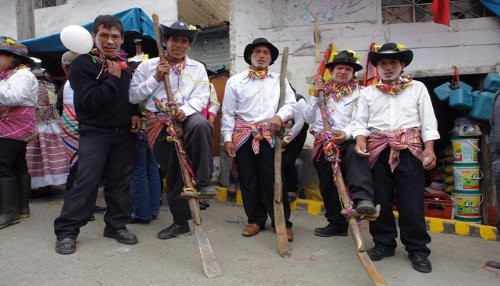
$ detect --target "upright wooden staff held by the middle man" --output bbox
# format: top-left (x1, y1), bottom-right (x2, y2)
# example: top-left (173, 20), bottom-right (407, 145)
top-left (273, 47), bottom-right (292, 257)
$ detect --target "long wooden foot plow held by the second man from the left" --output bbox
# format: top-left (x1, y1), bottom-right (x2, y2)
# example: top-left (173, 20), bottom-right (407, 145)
top-left (152, 14), bottom-right (222, 278)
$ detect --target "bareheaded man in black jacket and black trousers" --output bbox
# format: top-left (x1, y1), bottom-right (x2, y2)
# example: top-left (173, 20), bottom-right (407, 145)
top-left (54, 15), bottom-right (141, 254)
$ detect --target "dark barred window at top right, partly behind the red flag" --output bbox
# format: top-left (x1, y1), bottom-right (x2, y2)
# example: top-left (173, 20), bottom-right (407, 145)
top-left (382, 0), bottom-right (494, 24)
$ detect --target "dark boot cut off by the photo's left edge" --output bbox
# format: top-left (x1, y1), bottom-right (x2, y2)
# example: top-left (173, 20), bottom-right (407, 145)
top-left (0, 177), bottom-right (20, 228)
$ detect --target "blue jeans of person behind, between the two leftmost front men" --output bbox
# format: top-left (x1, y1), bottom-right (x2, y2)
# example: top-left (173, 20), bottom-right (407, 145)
top-left (130, 140), bottom-right (161, 220)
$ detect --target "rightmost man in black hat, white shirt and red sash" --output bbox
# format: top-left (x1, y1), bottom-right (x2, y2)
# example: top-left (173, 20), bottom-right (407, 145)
top-left (353, 43), bottom-right (439, 273)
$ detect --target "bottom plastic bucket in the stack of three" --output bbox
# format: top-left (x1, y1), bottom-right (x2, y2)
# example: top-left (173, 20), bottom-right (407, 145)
top-left (452, 194), bottom-right (482, 223)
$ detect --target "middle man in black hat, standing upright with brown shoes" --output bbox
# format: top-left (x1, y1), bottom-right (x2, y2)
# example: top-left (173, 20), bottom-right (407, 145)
top-left (221, 38), bottom-right (297, 241)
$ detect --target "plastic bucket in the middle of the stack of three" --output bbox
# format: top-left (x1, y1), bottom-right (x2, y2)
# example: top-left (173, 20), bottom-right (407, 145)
top-left (453, 164), bottom-right (481, 193)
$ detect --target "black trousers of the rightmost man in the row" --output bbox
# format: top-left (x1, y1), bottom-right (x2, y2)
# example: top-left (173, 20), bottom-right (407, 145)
top-left (370, 147), bottom-right (431, 256)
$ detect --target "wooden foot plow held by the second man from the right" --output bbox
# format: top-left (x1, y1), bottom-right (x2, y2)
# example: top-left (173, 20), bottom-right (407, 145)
top-left (320, 91), bottom-right (387, 286)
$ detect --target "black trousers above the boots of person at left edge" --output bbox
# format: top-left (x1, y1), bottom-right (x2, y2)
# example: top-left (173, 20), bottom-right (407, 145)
top-left (0, 138), bottom-right (28, 178)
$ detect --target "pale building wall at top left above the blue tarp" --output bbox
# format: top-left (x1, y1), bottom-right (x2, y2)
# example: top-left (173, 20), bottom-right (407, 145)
top-left (0, 0), bottom-right (177, 38)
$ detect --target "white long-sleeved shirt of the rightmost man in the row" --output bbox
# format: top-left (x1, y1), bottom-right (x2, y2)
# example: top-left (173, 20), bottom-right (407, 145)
top-left (353, 80), bottom-right (439, 142)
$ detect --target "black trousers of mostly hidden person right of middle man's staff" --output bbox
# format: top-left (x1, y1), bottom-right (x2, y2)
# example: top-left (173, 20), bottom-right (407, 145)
top-left (282, 124), bottom-right (309, 192)
